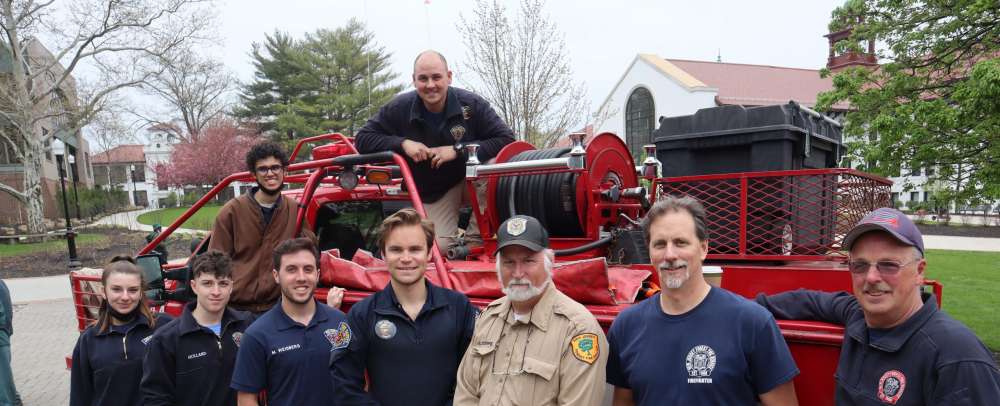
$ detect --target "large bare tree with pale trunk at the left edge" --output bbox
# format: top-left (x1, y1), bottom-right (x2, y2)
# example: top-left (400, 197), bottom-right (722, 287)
top-left (0, 0), bottom-right (214, 232)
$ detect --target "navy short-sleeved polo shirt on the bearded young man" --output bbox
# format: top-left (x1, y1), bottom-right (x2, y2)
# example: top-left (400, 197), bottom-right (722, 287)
top-left (231, 299), bottom-right (354, 406)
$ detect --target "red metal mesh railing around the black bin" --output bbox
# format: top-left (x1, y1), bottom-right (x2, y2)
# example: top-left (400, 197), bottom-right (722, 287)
top-left (656, 168), bottom-right (892, 261)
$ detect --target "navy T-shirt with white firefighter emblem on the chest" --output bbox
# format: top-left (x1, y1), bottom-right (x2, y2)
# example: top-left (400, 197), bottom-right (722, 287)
top-left (607, 287), bottom-right (799, 405)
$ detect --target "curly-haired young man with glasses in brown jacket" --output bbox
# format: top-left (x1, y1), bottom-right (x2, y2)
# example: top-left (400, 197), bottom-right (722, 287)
top-left (209, 141), bottom-right (316, 313)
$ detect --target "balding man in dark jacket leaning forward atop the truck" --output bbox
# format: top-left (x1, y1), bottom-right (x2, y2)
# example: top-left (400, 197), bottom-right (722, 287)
top-left (355, 51), bottom-right (514, 250)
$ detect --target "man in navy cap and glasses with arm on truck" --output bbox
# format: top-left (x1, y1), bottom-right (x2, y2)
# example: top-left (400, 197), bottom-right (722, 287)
top-left (757, 208), bottom-right (1000, 405)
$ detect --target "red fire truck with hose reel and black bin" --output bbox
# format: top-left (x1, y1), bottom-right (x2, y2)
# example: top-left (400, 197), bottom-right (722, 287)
top-left (71, 103), bottom-right (941, 405)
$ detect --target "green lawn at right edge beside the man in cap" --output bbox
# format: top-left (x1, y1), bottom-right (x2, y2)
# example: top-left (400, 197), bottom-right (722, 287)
top-left (925, 250), bottom-right (1000, 351)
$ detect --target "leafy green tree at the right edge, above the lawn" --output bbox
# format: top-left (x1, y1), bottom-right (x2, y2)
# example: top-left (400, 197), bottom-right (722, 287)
top-left (818, 0), bottom-right (1000, 208)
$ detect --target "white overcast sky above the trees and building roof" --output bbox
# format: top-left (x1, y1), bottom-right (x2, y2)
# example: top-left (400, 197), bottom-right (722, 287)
top-left (212, 0), bottom-right (844, 109)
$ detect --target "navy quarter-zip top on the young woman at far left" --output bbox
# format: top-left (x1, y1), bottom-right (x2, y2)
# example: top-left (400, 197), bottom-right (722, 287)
top-left (69, 314), bottom-right (172, 406)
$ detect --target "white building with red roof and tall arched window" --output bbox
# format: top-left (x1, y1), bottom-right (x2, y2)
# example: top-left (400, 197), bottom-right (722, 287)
top-left (593, 48), bottom-right (933, 213)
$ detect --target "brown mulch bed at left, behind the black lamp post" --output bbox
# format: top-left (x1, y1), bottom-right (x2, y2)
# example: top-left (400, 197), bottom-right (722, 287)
top-left (0, 228), bottom-right (190, 279)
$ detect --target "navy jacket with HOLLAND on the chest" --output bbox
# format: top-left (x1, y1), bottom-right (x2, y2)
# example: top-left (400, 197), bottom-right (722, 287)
top-left (141, 302), bottom-right (253, 406)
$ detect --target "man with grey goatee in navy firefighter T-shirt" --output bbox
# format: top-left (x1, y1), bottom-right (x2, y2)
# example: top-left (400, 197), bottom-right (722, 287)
top-left (607, 196), bottom-right (799, 406)
